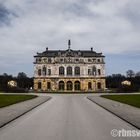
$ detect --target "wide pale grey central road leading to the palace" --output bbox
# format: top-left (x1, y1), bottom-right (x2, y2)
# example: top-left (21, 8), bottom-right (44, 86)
top-left (0, 95), bottom-right (139, 140)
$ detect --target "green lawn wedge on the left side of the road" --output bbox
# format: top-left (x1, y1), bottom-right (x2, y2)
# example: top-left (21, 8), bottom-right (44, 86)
top-left (0, 95), bottom-right (37, 108)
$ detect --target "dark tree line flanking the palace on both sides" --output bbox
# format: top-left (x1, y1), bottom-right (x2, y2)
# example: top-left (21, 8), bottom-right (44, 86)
top-left (0, 70), bottom-right (140, 92)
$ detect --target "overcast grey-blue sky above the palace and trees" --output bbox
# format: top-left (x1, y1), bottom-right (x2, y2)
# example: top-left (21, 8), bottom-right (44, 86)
top-left (0, 0), bottom-right (140, 76)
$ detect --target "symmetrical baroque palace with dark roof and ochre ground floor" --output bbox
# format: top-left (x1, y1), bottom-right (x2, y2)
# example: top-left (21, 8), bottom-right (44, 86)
top-left (34, 40), bottom-right (105, 92)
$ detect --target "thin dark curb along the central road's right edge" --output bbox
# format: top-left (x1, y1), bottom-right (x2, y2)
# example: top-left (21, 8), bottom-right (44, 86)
top-left (87, 97), bottom-right (140, 129)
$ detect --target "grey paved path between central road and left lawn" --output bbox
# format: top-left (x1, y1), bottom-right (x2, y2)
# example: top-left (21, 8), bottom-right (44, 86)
top-left (0, 96), bottom-right (51, 127)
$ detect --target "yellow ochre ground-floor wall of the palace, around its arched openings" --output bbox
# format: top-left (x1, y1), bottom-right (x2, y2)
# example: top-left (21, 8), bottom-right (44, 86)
top-left (34, 78), bottom-right (106, 92)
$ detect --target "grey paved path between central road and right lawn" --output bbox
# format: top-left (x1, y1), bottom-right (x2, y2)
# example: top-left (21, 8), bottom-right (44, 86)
top-left (88, 96), bottom-right (140, 129)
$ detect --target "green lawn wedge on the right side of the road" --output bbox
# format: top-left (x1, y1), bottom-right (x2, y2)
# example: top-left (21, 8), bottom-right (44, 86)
top-left (101, 94), bottom-right (140, 108)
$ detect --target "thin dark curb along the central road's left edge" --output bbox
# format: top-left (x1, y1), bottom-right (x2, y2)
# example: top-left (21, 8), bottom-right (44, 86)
top-left (0, 96), bottom-right (52, 128)
